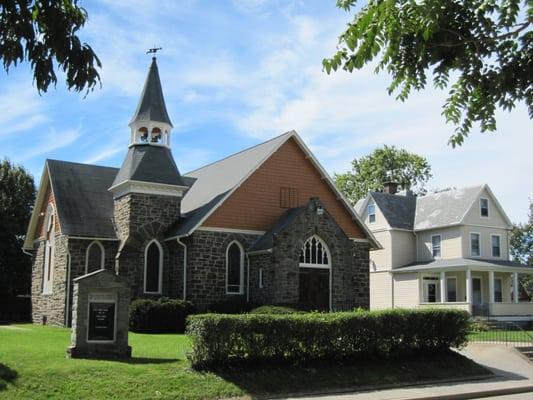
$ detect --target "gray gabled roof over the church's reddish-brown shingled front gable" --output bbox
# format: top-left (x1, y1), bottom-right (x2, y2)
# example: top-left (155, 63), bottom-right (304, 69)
top-left (167, 131), bottom-right (381, 249)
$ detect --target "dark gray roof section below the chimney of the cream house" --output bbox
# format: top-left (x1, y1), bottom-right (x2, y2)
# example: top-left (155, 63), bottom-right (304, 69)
top-left (370, 192), bottom-right (416, 230)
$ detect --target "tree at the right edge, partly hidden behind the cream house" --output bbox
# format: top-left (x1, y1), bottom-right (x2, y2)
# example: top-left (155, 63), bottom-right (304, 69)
top-left (510, 202), bottom-right (533, 300)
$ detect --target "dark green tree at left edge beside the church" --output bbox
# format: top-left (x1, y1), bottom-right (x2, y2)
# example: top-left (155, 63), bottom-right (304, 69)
top-left (0, 159), bottom-right (35, 297)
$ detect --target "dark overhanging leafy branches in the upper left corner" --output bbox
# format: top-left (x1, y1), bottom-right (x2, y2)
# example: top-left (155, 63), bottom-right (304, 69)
top-left (0, 0), bottom-right (101, 92)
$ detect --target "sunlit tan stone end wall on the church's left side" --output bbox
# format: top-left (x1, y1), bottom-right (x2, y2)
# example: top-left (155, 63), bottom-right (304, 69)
top-left (31, 232), bottom-right (68, 326)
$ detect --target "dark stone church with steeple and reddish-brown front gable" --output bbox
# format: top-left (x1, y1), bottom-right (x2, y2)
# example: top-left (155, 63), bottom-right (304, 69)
top-left (24, 58), bottom-right (379, 326)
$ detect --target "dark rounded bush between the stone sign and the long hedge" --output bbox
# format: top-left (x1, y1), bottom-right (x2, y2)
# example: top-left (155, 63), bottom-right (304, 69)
top-left (130, 297), bottom-right (194, 333)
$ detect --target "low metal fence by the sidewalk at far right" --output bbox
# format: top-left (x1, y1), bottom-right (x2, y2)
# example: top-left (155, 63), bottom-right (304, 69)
top-left (468, 321), bottom-right (533, 347)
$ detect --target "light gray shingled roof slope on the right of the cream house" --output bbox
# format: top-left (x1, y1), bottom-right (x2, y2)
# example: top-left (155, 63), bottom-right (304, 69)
top-left (414, 185), bottom-right (484, 230)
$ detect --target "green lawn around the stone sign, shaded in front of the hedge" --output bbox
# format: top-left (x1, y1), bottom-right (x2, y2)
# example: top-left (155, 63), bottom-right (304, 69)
top-left (0, 325), bottom-right (488, 400)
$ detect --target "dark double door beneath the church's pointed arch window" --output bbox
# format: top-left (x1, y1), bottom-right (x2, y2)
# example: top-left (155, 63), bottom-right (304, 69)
top-left (300, 267), bottom-right (330, 311)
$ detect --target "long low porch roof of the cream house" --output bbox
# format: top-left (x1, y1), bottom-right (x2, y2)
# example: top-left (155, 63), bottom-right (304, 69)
top-left (393, 258), bottom-right (533, 273)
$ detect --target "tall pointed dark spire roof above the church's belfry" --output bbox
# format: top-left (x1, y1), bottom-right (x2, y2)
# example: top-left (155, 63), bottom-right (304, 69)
top-left (130, 57), bottom-right (172, 126)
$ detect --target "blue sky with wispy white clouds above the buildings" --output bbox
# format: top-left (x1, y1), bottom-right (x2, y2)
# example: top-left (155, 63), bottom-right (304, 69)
top-left (0, 0), bottom-right (533, 222)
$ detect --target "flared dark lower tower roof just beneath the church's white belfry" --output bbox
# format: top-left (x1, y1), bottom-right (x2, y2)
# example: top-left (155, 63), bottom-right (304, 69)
top-left (110, 144), bottom-right (187, 186)
